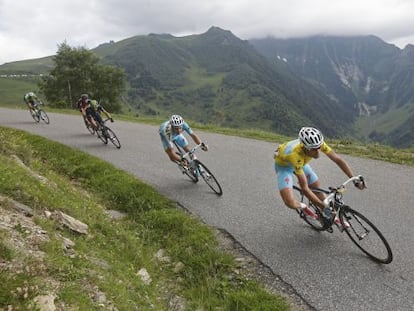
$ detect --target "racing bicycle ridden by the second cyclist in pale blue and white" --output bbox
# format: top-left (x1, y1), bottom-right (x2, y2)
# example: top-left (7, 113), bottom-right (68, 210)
top-left (174, 141), bottom-right (223, 195)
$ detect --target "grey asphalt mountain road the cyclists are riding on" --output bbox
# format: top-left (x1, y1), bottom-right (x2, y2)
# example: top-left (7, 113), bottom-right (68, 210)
top-left (0, 108), bottom-right (414, 311)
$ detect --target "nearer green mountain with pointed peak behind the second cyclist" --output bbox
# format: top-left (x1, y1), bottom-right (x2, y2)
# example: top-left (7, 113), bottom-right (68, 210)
top-left (94, 27), bottom-right (353, 136)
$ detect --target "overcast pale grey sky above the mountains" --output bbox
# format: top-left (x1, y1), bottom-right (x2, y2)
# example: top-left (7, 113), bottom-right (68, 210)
top-left (0, 0), bottom-right (414, 65)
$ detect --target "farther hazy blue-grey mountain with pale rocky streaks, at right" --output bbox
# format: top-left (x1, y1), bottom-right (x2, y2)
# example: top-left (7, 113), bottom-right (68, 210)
top-left (249, 36), bottom-right (414, 147)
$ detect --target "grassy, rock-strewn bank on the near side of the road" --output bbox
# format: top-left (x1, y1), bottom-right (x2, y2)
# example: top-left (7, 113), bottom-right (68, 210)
top-left (0, 127), bottom-right (290, 310)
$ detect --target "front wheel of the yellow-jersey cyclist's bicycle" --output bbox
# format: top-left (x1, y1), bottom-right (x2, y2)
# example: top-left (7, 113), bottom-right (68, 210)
top-left (339, 206), bottom-right (393, 264)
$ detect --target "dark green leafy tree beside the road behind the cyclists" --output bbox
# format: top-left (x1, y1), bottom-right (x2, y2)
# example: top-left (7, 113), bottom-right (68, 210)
top-left (40, 42), bottom-right (125, 112)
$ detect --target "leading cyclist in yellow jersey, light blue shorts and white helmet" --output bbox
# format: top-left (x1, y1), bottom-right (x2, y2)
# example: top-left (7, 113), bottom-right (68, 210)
top-left (274, 127), bottom-right (365, 224)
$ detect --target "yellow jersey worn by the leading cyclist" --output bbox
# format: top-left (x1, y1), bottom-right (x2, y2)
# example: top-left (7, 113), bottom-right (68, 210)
top-left (274, 139), bottom-right (332, 175)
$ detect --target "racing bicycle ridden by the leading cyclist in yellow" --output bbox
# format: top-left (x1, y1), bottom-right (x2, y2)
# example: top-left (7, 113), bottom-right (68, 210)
top-left (293, 176), bottom-right (393, 264)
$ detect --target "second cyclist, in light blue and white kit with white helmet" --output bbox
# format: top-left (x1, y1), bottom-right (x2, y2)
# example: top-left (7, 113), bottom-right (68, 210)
top-left (159, 114), bottom-right (208, 167)
